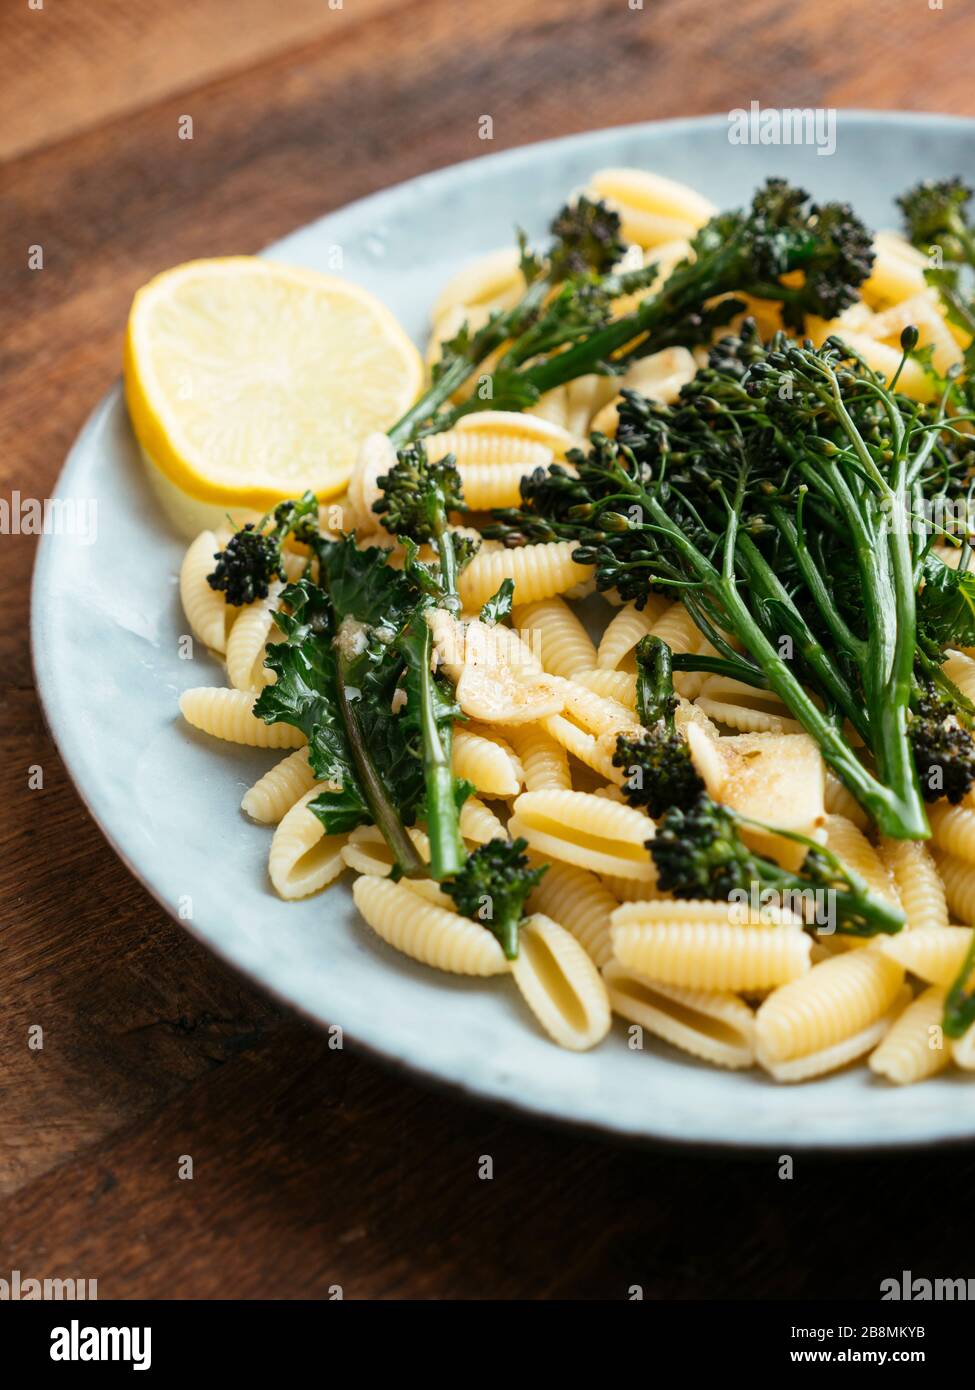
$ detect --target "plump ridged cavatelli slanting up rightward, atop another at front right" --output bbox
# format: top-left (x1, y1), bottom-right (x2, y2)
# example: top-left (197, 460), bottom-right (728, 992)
top-left (755, 949), bottom-right (904, 1063)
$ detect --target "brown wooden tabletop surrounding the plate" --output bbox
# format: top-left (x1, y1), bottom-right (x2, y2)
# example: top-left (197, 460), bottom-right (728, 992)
top-left (0, 0), bottom-right (975, 1298)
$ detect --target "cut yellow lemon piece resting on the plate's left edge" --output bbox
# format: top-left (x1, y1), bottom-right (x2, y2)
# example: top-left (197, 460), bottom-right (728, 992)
top-left (125, 256), bottom-right (423, 521)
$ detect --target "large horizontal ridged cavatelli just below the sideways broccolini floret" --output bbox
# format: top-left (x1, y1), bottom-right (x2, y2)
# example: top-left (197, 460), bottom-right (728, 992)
top-left (611, 901), bottom-right (812, 991)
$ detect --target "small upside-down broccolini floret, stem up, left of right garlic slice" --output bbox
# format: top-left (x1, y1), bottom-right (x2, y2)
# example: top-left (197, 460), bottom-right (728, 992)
top-left (613, 637), bottom-right (704, 819)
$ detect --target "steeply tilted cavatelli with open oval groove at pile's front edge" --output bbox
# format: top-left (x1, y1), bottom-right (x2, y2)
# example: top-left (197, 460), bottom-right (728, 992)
top-left (510, 913), bottom-right (611, 1052)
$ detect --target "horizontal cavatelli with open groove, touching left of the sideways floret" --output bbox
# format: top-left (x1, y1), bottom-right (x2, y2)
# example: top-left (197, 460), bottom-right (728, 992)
top-left (508, 791), bottom-right (656, 881)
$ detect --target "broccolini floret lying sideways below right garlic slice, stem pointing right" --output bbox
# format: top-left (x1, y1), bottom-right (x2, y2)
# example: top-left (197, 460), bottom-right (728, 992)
top-left (647, 795), bottom-right (904, 937)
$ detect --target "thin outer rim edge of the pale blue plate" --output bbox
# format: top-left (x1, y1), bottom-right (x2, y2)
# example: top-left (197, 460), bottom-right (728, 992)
top-left (29, 108), bottom-right (975, 1158)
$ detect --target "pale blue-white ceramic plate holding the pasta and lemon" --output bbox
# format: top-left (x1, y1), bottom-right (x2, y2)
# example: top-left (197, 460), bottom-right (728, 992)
top-left (32, 113), bottom-right (975, 1151)
